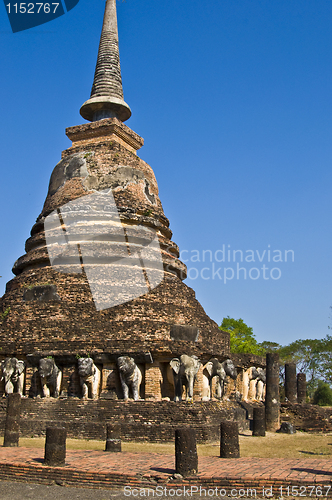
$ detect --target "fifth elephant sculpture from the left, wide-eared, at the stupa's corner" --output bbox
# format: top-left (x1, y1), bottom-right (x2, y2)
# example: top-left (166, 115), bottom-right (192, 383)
top-left (169, 354), bottom-right (202, 401)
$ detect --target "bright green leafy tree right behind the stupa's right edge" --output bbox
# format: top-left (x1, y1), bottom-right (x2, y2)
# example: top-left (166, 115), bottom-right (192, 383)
top-left (219, 316), bottom-right (265, 356)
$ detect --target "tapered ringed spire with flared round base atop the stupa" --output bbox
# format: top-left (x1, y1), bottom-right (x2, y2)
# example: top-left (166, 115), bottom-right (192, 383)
top-left (80, 0), bottom-right (131, 122)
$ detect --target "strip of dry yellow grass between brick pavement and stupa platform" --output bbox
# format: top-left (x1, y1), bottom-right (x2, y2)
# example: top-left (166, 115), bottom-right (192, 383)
top-left (20, 432), bottom-right (332, 459)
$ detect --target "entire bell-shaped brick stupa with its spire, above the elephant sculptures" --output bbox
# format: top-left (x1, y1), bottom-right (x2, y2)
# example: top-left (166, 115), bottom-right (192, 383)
top-left (0, 0), bottom-right (229, 398)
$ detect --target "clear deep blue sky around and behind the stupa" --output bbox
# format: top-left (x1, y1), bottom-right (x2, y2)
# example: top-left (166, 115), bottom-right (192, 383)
top-left (0, 0), bottom-right (332, 344)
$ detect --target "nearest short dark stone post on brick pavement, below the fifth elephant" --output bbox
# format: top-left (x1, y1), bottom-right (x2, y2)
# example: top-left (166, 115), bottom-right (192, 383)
top-left (175, 427), bottom-right (198, 477)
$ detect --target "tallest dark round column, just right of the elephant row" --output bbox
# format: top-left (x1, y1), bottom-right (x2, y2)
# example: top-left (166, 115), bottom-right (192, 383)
top-left (265, 352), bottom-right (280, 432)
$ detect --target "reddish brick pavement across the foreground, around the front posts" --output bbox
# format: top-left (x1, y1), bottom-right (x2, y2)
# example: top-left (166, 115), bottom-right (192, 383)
top-left (0, 447), bottom-right (332, 497)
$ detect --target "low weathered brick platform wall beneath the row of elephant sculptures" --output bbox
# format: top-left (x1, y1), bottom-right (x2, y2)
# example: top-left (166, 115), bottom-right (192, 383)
top-left (0, 398), bottom-right (245, 442)
